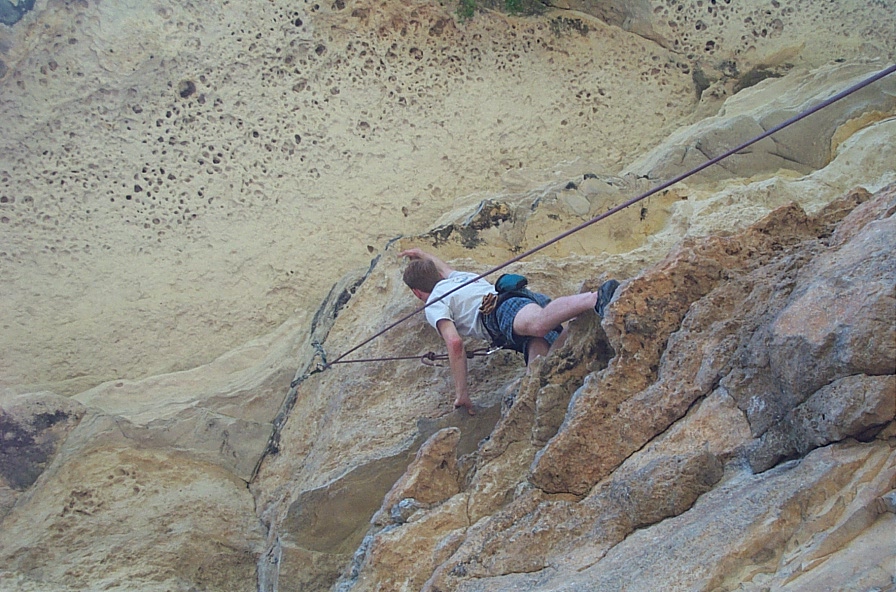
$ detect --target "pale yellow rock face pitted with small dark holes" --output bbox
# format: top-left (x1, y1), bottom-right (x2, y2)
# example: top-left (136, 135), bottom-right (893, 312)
top-left (0, 0), bottom-right (697, 394)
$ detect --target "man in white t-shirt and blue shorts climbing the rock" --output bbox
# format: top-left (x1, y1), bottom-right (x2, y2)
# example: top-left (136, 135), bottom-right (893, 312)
top-left (399, 249), bottom-right (619, 415)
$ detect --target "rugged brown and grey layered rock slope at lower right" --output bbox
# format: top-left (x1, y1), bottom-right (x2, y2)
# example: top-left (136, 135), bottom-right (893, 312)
top-left (338, 186), bottom-right (896, 591)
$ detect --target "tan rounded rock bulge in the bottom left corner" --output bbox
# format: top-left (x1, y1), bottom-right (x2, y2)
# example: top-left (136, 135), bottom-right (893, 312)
top-left (0, 413), bottom-right (263, 591)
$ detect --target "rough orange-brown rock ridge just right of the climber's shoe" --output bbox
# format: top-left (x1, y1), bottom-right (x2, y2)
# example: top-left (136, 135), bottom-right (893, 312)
top-left (531, 205), bottom-right (814, 495)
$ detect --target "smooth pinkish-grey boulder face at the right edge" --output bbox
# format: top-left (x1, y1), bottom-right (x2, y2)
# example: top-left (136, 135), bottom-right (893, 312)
top-left (722, 189), bottom-right (896, 438)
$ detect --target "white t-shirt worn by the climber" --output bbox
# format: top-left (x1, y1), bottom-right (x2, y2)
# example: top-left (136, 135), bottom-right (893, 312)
top-left (423, 271), bottom-right (495, 341)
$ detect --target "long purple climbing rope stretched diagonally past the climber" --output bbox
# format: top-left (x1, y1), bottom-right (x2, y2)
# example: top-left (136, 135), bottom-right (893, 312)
top-left (320, 64), bottom-right (896, 370)
